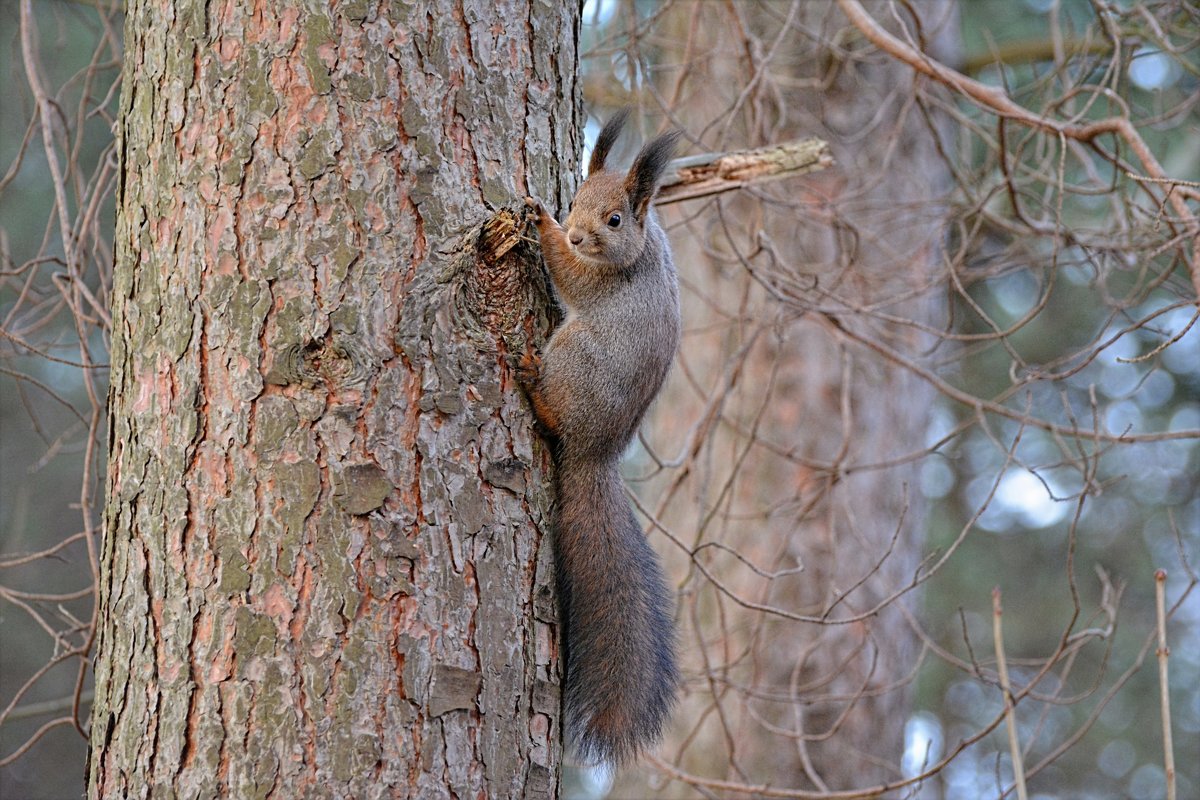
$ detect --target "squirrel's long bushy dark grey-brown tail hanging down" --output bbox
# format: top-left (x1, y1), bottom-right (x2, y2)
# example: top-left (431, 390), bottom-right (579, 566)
top-left (554, 453), bottom-right (679, 763)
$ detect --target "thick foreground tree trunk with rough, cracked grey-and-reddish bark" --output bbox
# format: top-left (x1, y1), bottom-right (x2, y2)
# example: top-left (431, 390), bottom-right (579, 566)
top-left (89, 0), bottom-right (581, 798)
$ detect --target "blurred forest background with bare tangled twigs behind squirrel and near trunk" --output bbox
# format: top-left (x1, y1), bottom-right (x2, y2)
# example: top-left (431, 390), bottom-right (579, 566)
top-left (0, 0), bottom-right (1200, 799)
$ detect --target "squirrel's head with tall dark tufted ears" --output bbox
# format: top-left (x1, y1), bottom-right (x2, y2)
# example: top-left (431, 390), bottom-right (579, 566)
top-left (565, 109), bottom-right (679, 266)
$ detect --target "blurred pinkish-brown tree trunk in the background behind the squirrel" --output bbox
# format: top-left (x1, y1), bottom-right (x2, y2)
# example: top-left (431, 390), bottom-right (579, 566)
top-left (620, 2), bottom-right (954, 796)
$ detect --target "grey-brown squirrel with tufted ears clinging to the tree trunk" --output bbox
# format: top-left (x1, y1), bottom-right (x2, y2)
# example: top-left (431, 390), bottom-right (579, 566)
top-left (517, 109), bottom-right (680, 764)
